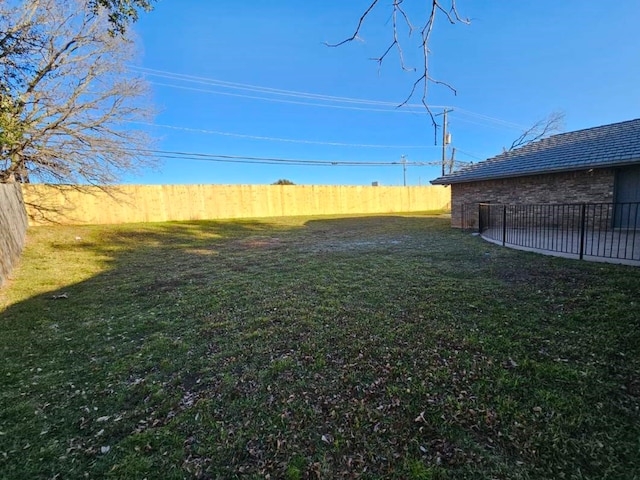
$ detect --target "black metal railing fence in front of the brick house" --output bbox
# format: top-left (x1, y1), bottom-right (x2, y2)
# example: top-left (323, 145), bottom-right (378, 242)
top-left (477, 203), bottom-right (640, 261)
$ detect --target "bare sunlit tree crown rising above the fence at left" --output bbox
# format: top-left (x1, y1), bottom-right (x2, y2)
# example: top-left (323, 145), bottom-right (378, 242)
top-left (0, 0), bottom-right (150, 185)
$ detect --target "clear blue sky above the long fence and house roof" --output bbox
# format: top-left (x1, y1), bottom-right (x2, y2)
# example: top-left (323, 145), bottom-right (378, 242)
top-left (125, 0), bottom-right (640, 185)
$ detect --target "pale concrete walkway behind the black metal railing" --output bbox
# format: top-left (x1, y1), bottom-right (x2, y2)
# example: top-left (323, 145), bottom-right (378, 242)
top-left (481, 227), bottom-right (640, 266)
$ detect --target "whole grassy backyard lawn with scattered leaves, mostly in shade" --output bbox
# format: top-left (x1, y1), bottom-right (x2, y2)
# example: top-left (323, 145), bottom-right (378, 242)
top-left (0, 215), bottom-right (640, 480)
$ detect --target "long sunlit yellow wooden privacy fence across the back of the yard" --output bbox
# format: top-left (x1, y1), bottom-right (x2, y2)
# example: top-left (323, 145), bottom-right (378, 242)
top-left (23, 184), bottom-right (451, 225)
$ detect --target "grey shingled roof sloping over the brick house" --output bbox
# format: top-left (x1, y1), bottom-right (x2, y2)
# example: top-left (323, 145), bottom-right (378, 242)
top-left (431, 118), bottom-right (640, 185)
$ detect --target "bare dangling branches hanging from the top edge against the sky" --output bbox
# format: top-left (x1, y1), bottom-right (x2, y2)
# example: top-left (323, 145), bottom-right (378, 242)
top-left (326, 0), bottom-right (470, 126)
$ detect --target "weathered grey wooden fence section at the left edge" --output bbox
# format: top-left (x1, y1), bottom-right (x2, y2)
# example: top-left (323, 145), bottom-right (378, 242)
top-left (0, 183), bottom-right (27, 286)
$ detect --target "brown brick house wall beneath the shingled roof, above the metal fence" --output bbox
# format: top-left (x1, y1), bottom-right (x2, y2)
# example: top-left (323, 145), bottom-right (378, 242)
top-left (451, 168), bottom-right (616, 228)
